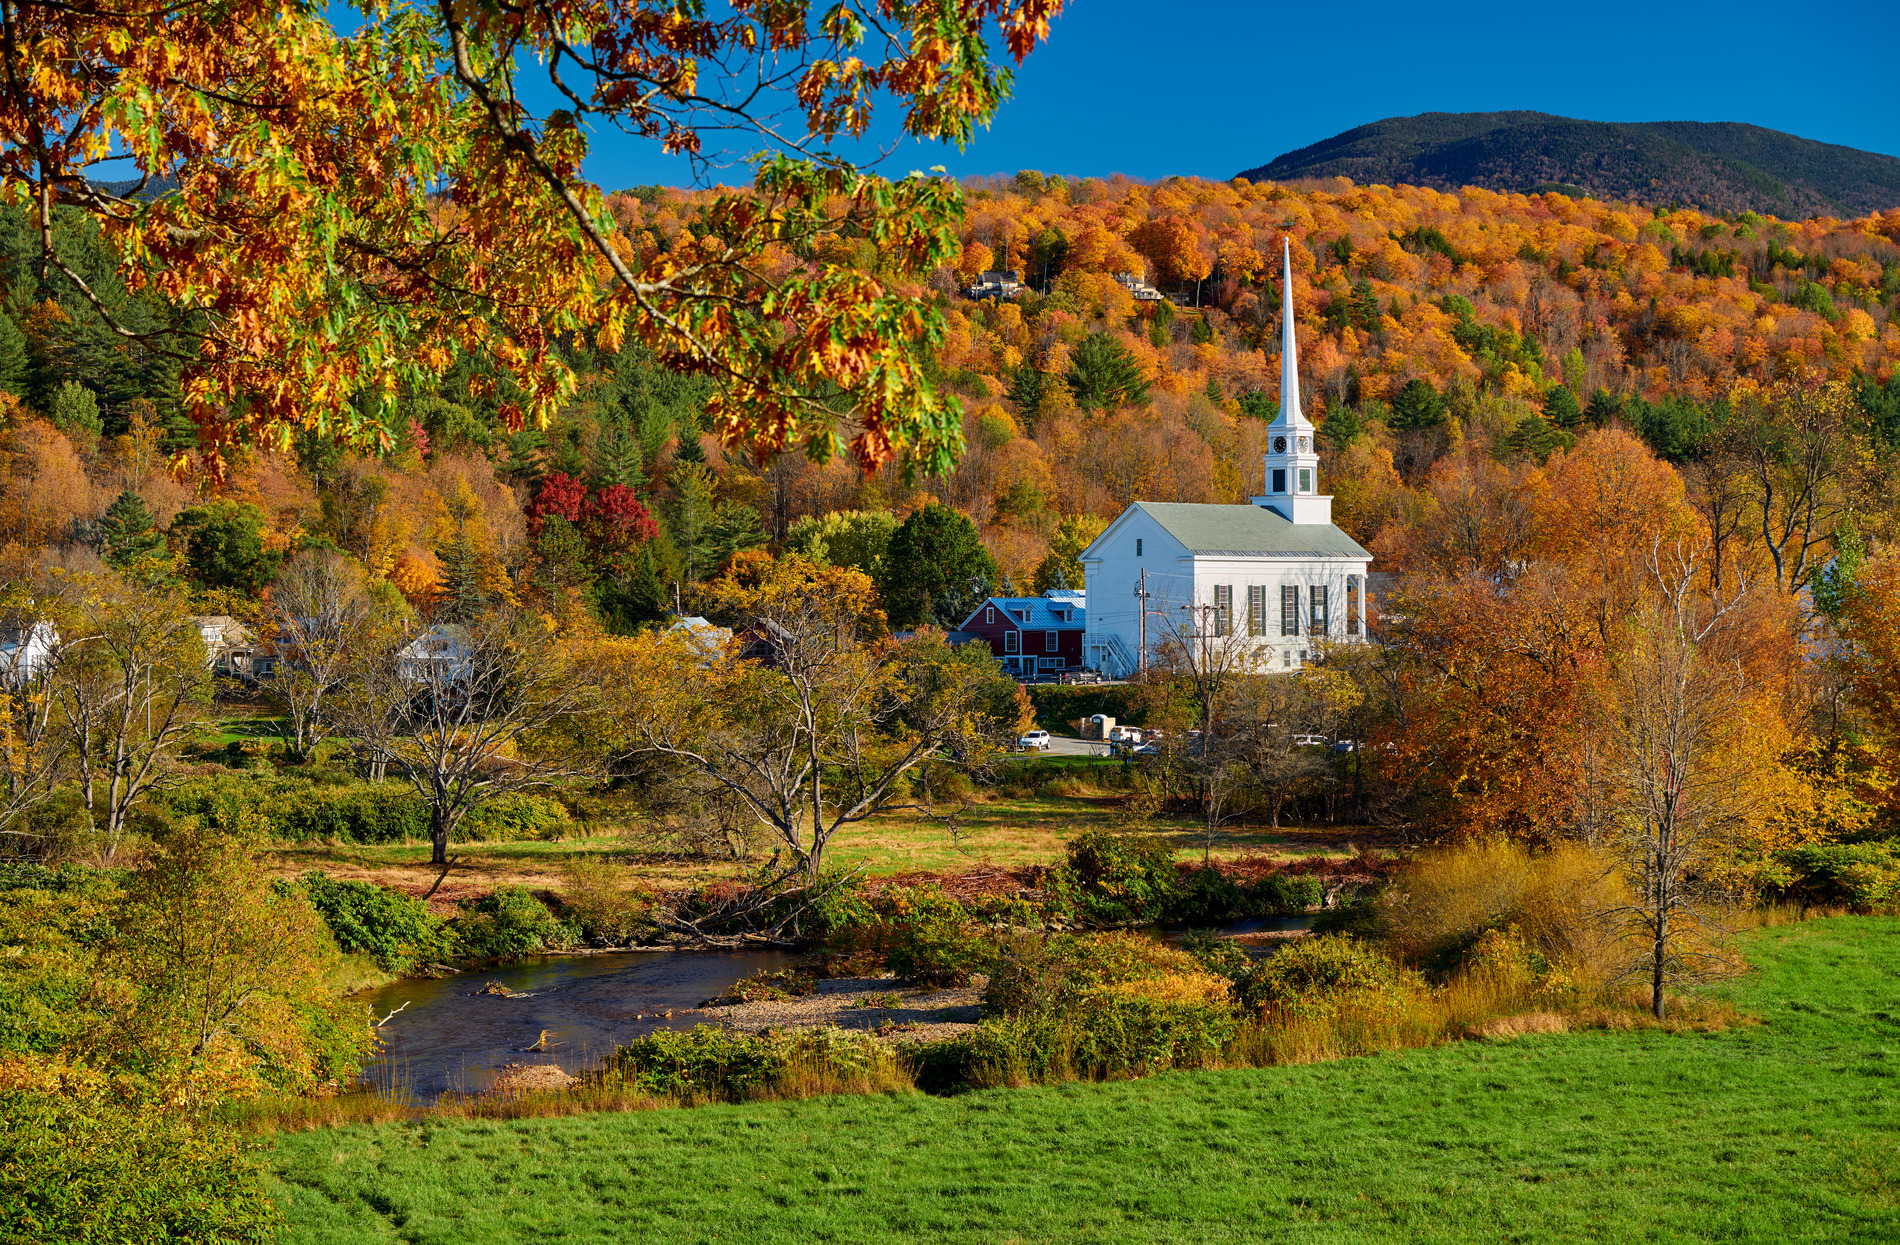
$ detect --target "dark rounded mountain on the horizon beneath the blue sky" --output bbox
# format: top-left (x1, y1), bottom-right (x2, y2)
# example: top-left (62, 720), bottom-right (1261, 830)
top-left (1241, 112), bottom-right (1900, 219)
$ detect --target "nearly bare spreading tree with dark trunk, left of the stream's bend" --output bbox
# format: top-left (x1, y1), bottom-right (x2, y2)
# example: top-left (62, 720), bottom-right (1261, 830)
top-left (331, 608), bottom-right (595, 871)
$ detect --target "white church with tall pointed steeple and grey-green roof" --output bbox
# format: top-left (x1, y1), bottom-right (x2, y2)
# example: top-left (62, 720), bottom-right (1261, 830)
top-left (1081, 245), bottom-right (1372, 679)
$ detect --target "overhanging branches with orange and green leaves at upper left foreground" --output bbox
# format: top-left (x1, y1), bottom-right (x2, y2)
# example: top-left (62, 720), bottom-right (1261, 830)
top-left (0, 0), bottom-right (1062, 471)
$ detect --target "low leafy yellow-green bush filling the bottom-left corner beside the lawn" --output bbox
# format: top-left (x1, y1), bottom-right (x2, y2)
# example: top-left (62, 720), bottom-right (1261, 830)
top-left (0, 1093), bottom-right (279, 1245)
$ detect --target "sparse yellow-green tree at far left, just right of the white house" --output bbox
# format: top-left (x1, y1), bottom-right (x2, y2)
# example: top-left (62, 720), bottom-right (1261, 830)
top-left (51, 578), bottom-right (211, 861)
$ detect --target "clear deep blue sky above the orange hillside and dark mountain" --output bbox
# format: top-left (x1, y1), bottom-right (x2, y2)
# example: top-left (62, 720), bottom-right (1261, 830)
top-left (587, 0), bottom-right (1900, 190)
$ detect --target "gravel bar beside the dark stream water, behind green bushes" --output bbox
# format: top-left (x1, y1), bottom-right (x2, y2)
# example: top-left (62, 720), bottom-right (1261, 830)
top-left (675, 977), bottom-right (984, 1042)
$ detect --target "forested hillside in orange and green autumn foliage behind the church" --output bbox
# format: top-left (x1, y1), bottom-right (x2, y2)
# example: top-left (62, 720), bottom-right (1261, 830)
top-left (0, 173), bottom-right (1900, 608)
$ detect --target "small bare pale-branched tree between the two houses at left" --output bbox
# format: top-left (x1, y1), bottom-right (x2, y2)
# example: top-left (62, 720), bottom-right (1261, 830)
top-left (270, 549), bottom-right (372, 755)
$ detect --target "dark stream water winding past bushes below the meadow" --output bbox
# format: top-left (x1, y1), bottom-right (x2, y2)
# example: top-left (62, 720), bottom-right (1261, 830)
top-left (363, 916), bottom-right (1313, 1101)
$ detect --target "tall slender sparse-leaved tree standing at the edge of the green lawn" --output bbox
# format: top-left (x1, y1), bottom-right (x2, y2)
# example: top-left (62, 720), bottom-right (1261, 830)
top-left (1602, 610), bottom-right (1763, 1019)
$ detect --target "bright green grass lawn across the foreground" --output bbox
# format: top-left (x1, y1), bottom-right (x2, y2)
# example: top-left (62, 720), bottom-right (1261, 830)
top-left (272, 918), bottom-right (1900, 1245)
